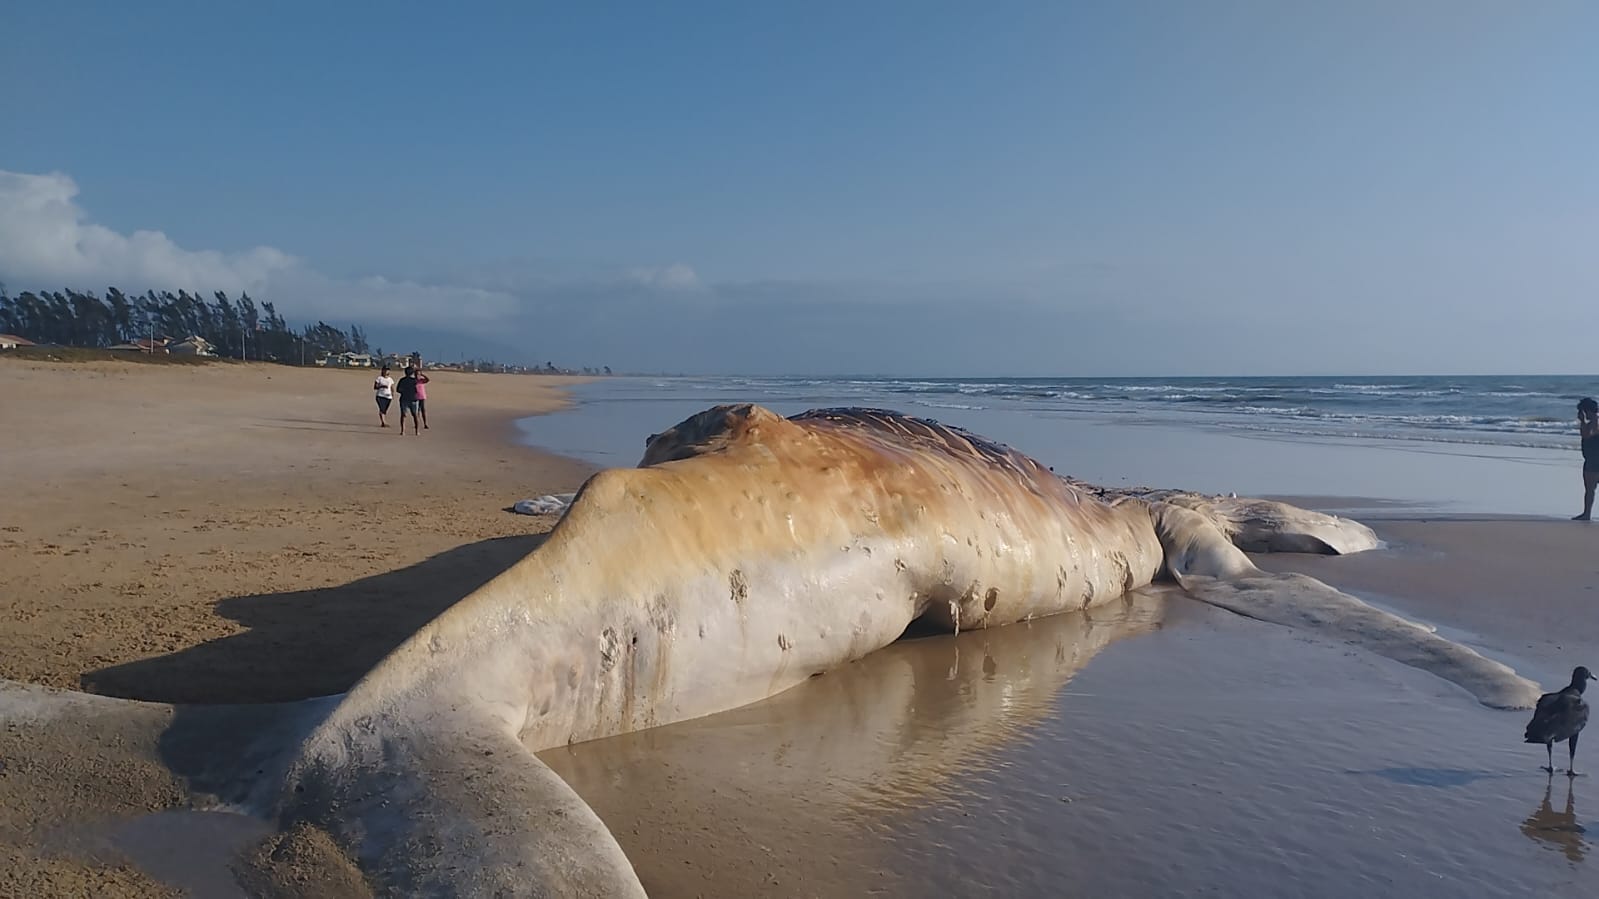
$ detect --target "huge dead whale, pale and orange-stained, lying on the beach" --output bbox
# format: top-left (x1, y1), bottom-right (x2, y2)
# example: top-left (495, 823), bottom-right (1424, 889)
top-left (0, 405), bottom-right (1538, 896)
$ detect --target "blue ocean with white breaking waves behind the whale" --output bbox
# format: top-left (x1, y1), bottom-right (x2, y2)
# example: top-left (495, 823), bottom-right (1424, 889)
top-left (523, 374), bottom-right (1599, 515)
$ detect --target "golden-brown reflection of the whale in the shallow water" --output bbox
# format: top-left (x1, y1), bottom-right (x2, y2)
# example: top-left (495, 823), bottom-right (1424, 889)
top-left (539, 587), bottom-right (1166, 896)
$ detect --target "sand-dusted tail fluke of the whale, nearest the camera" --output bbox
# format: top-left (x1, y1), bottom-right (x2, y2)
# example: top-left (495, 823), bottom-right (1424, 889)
top-left (278, 709), bottom-right (644, 899)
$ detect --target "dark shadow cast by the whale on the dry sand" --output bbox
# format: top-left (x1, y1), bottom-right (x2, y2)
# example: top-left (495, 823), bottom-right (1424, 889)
top-left (82, 534), bottom-right (544, 704)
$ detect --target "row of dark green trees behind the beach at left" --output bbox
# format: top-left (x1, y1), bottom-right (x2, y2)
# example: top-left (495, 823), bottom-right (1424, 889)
top-left (0, 286), bottom-right (368, 363)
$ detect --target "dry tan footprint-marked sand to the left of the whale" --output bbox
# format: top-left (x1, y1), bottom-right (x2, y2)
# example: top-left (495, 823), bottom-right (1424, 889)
top-left (0, 358), bottom-right (590, 896)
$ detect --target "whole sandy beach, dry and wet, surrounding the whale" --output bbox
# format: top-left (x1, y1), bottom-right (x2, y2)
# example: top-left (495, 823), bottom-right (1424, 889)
top-left (0, 360), bottom-right (1599, 897)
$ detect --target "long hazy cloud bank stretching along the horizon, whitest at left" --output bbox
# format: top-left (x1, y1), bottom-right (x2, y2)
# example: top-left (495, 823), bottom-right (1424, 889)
top-left (24, 170), bottom-right (1522, 374)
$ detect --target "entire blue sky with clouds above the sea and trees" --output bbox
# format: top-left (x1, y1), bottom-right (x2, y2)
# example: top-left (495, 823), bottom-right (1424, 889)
top-left (0, 0), bottom-right (1599, 374)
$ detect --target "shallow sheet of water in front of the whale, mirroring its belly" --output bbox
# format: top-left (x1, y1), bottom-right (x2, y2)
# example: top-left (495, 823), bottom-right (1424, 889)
top-left (540, 589), bottom-right (1599, 897)
